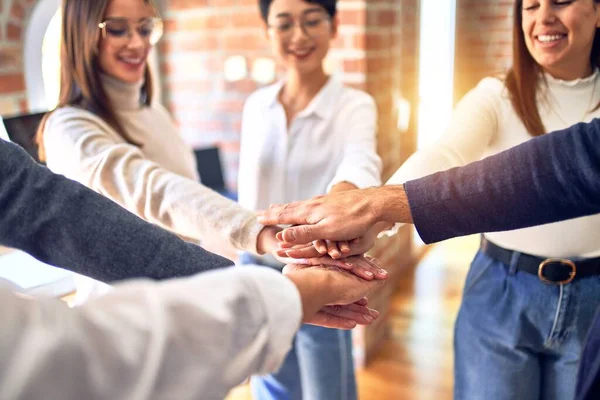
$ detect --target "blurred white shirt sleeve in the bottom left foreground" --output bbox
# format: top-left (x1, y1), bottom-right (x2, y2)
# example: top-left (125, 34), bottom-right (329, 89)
top-left (0, 267), bottom-right (302, 400)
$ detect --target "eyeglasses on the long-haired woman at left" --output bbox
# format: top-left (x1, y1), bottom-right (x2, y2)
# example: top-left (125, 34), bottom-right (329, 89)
top-left (98, 18), bottom-right (163, 45)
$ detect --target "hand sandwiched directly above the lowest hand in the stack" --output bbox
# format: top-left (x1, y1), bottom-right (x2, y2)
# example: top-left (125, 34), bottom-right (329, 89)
top-left (273, 250), bottom-right (388, 280)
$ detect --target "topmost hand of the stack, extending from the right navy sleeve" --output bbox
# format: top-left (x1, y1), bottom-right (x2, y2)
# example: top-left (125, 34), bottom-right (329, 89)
top-left (258, 185), bottom-right (412, 244)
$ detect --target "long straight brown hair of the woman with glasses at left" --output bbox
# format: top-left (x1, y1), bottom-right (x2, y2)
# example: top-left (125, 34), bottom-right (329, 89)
top-left (36, 0), bottom-right (154, 161)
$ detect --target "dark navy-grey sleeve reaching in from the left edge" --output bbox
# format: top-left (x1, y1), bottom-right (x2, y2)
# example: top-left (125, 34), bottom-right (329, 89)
top-left (0, 140), bottom-right (233, 282)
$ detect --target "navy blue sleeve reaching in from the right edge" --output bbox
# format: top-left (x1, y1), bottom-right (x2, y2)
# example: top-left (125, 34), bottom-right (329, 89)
top-left (405, 119), bottom-right (600, 243)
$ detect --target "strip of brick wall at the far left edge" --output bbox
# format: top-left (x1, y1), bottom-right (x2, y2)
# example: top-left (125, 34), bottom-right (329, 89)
top-left (0, 0), bottom-right (36, 115)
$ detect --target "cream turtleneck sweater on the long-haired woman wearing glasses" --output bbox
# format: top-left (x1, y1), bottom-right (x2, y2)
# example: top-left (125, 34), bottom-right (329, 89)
top-left (44, 76), bottom-right (262, 252)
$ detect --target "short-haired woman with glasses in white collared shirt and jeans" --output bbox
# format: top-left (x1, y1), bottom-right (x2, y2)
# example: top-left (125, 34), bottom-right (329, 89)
top-left (238, 0), bottom-right (381, 400)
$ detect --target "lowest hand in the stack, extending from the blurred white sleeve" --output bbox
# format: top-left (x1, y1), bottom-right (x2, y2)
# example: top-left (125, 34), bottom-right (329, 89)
top-left (283, 264), bottom-right (383, 329)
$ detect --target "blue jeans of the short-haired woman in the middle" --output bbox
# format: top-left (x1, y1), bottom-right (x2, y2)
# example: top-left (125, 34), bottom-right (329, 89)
top-left (240, 254), bottom-right (358, 400)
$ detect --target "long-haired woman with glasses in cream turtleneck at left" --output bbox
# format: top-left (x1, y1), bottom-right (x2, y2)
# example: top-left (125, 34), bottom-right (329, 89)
top-left (37, 0), bottom-right (292, 300)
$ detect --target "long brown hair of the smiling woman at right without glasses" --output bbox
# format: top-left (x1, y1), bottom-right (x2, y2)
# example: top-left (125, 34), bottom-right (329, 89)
top-left (504, 0), bottom-right (600, 136)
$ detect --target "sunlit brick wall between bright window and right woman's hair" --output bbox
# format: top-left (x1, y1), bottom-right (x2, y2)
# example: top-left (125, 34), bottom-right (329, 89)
top-left (454, 0), bottom-right (514, 101)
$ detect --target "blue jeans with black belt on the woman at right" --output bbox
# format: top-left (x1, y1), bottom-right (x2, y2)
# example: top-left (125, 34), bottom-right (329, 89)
top-left (454, 252), bottom-right (600, 400)
